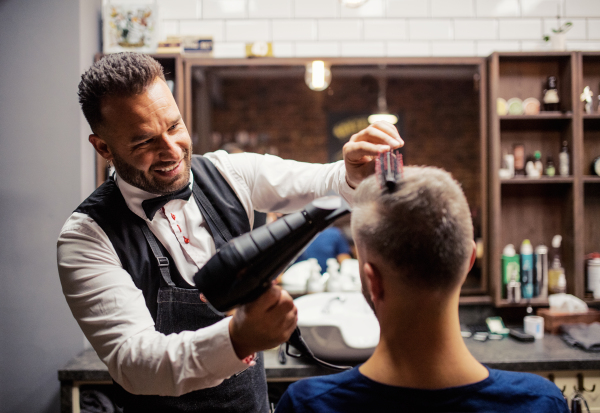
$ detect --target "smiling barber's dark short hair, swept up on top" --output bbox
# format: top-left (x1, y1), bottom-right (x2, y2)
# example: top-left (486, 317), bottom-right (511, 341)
top-left (78, 52), bottom-right (165, 133)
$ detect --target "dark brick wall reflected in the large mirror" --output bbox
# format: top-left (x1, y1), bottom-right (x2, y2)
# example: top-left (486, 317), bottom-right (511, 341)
top-left (212, 71), bottom-right (481, 219)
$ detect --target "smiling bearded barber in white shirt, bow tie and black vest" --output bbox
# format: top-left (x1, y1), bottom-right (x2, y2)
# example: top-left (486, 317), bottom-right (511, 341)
top-left (58, 53), bottom-right (403, 413)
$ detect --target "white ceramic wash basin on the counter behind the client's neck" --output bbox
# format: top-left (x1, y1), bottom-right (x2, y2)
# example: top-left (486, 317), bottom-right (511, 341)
top-left (294, 292), bottom-right (379, 361)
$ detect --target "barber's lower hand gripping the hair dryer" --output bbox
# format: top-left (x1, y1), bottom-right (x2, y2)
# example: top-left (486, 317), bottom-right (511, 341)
top-left (229, 285), bottom-right (298, 360)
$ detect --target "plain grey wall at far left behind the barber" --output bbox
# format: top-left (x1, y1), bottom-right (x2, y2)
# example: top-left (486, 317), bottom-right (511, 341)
top-left (0, 0), bottom-right (99, 413)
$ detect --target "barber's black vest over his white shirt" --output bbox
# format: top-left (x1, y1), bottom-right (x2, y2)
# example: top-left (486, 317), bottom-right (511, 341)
top-left (75, 155), bottom-right (250, 321)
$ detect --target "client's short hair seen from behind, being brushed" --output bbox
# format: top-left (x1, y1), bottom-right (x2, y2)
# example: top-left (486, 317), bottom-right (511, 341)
top-left (352, 167), bottom-right (473, 290)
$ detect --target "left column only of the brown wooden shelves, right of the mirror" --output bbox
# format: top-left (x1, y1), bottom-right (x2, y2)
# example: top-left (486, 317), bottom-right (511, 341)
top-left (488, 52), bottom-right (581, 307)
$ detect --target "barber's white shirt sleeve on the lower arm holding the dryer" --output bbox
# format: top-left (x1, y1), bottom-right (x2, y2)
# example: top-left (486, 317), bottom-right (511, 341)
top-left (57, 213), bottom-right (248, 396)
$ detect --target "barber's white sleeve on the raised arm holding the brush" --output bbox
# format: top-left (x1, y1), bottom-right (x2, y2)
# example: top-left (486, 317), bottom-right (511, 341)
top-left (207, 151), bottom-right (354, 213)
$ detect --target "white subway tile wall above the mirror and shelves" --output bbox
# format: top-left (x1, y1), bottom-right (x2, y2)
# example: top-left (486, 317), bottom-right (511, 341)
top-left (158, 0), bottom-right (600, 58)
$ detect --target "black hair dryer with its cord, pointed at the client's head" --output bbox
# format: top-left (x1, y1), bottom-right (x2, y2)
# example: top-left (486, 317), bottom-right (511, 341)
top-left (194, 196), bottom-right (350, 369)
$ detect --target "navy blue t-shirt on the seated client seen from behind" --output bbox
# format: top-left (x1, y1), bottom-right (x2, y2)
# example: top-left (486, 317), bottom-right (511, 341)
top-left (275, 367), bottom-right (569, 413)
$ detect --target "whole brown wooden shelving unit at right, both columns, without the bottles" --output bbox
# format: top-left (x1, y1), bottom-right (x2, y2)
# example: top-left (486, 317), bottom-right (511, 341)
top-left (488, 52), bottom-right (600, 307)
